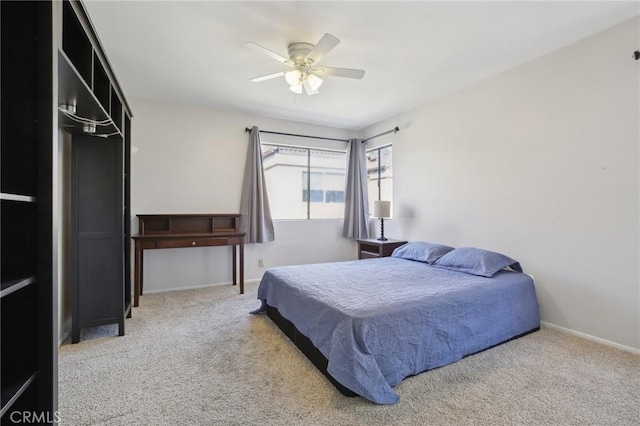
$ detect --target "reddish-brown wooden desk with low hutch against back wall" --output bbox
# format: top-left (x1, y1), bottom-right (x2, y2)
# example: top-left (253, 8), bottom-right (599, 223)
top-left (132, 213), bottom-right (245, 306)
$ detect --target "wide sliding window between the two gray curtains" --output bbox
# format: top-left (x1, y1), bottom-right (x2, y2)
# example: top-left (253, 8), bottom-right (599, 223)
top-left (262, 143), bottom-right (346, 219)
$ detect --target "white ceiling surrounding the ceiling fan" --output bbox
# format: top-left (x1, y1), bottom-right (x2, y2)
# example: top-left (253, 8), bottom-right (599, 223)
top-left (85, 0), bottom-right (640, 130)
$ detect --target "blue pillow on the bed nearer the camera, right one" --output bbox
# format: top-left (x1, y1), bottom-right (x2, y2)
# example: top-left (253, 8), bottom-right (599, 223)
top-left (434, 247), bottom-right (522, 278)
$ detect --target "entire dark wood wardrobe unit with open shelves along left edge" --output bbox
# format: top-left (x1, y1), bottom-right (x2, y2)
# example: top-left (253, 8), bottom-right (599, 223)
top-left (0, 0), bottom-right (132, 425)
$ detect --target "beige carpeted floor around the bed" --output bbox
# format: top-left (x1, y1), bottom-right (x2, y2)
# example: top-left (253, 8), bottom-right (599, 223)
top-left (59, 284), bottom-right (640, 426)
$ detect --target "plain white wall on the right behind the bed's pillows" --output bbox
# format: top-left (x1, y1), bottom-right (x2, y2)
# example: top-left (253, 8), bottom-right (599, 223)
top-left (365, 19), bottom-right (640, 349)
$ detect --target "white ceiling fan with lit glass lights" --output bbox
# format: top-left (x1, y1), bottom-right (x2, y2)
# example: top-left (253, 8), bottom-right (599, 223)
top-left (244, 33), bottom-right (364, 95)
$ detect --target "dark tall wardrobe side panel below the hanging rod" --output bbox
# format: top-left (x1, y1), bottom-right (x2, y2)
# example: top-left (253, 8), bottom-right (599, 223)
top-left (71, 134), bottom-right (125, 343)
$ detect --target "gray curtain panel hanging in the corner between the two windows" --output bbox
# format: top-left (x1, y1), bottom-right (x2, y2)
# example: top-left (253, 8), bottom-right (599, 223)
top-left (342, 139), bottom-right (369, 238)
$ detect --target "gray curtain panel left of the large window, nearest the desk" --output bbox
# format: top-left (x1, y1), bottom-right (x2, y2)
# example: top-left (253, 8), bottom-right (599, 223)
top-left (240, 126), bottom-right (275, 243)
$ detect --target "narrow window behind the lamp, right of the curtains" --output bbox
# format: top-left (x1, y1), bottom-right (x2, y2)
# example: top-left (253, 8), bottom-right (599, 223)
top-left (367, 145), bottom-right (393, 214)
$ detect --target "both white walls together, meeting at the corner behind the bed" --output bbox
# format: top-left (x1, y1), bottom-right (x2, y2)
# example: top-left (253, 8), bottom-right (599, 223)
top-left (127, 19), bottom-right (640, 348)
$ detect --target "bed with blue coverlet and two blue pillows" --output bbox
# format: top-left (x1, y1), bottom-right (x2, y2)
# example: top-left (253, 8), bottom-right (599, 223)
top-left (254, 242), bottom-right (540, 404)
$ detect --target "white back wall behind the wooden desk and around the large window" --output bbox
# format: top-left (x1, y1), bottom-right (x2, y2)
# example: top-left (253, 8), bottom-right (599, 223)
top-left (131, 100), bottom-right (357, 292)
